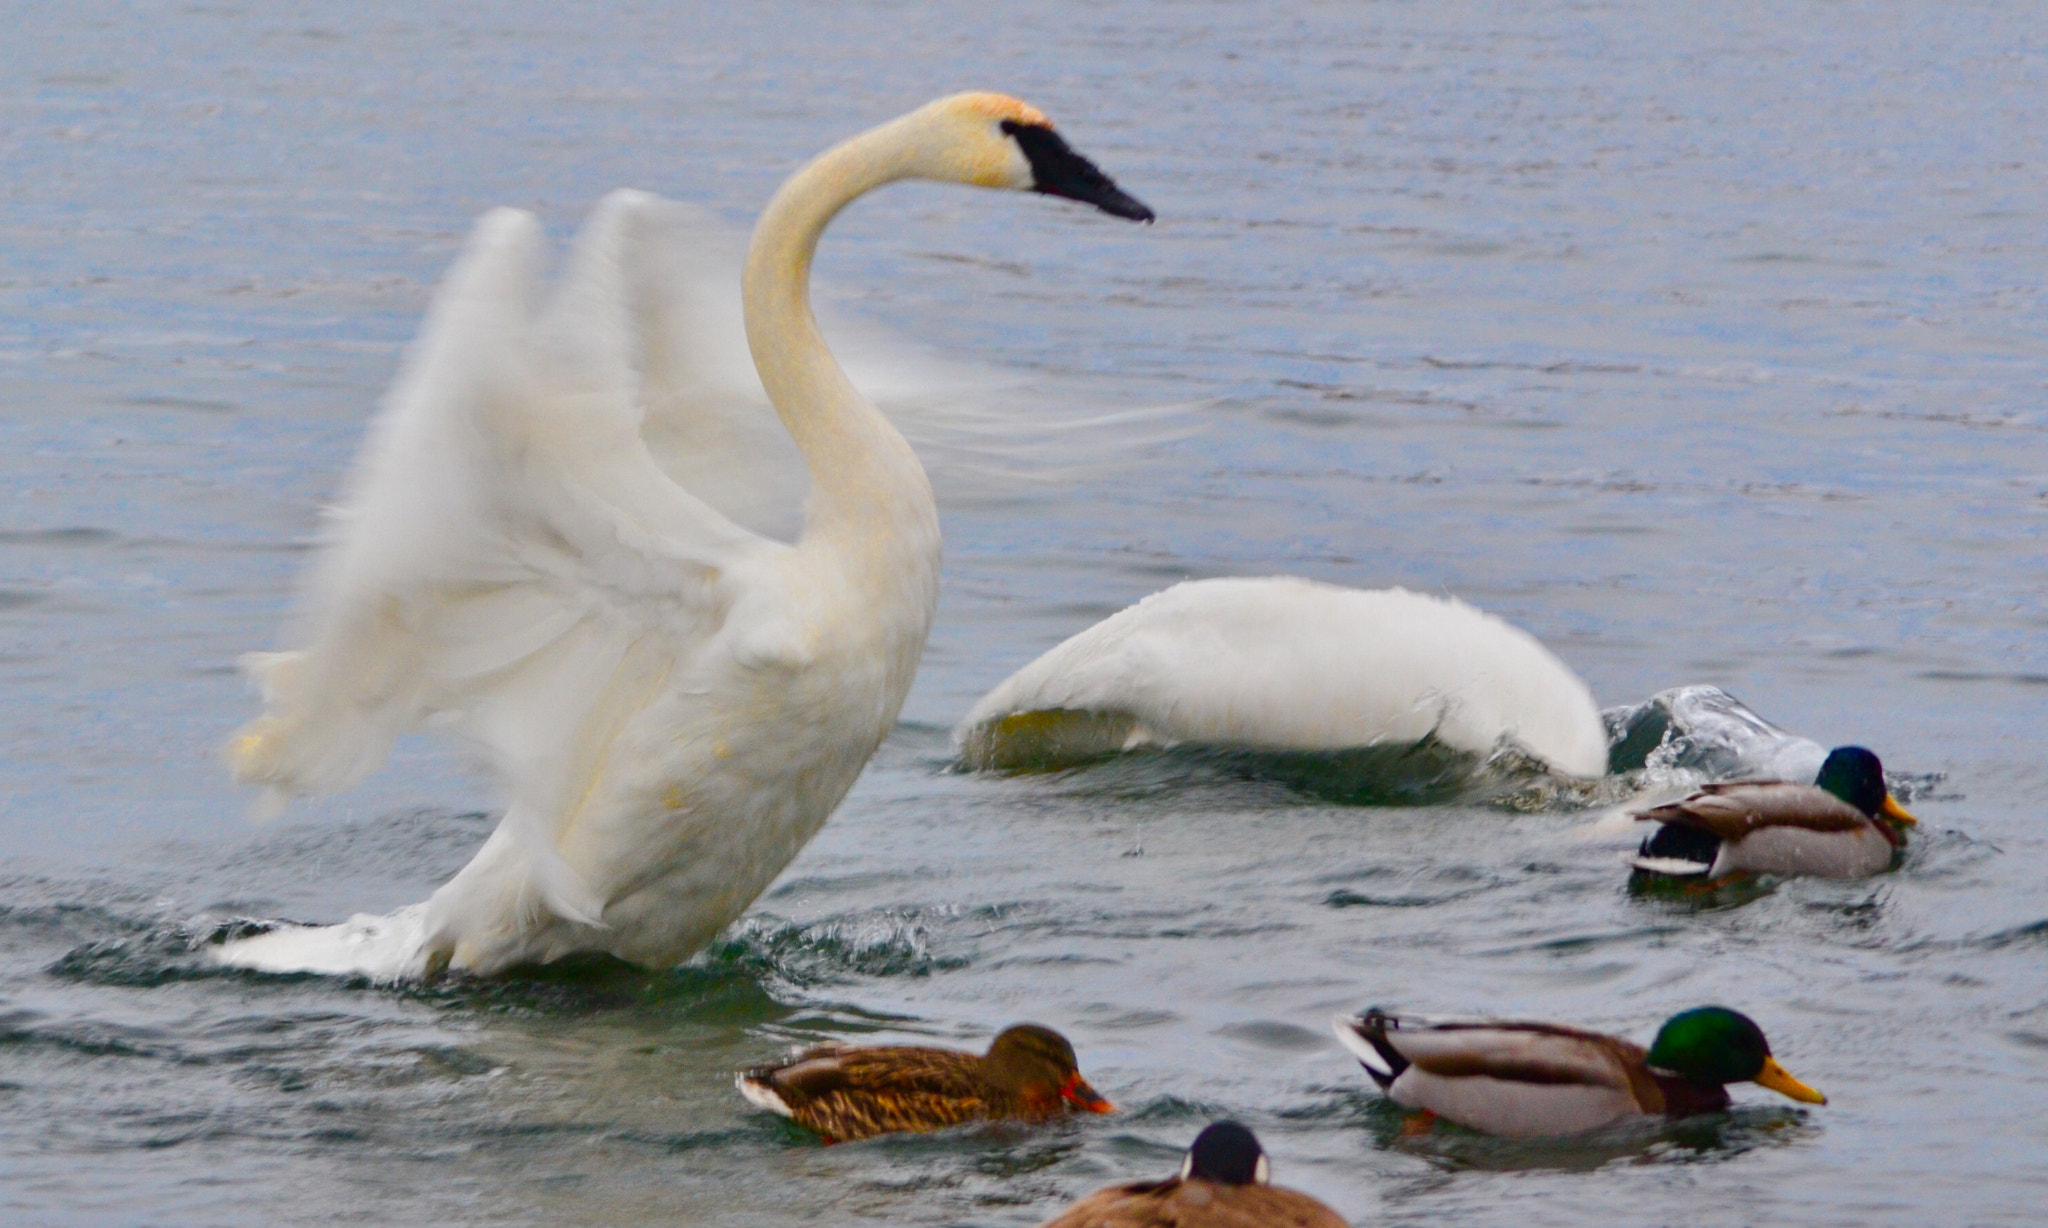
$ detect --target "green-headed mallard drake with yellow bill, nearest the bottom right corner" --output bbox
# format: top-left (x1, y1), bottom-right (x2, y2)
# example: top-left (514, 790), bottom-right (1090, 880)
top-left (1335, 1007), bottom-right (1827, 1138)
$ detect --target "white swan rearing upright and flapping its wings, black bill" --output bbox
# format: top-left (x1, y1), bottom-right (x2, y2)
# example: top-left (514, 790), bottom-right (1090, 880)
top-left (219, 94), bottom-right (1151, 978)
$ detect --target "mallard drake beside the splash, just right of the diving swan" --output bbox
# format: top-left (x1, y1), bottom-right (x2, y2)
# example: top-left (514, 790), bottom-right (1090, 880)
top-left (1634, 747), bottom-right (1917, 880)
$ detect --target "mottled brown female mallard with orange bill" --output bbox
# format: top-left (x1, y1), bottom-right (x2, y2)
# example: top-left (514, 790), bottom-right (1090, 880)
top-left (739, 1023), bottom-right (1116, 1142)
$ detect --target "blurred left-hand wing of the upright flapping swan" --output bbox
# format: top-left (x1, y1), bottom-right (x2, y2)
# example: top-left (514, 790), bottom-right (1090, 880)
top-left (229, 192), bottom-right (784, 915)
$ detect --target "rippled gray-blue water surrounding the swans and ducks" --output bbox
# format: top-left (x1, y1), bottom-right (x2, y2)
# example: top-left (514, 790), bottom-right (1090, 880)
top-left (0, 0), bottom-right (2048, 1226)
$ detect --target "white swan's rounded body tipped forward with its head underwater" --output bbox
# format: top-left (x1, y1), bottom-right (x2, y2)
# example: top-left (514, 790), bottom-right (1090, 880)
top-left (954, 575), bottom-right (1608, 776)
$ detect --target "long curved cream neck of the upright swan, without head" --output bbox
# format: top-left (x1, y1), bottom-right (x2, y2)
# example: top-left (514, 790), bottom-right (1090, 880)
top-left (743, 117), bottom-right (938, 551)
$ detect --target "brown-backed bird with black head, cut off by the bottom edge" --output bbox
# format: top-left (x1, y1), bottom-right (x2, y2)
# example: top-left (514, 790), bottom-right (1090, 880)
top-left (1044, 1122), bottom-right (1346, 1228)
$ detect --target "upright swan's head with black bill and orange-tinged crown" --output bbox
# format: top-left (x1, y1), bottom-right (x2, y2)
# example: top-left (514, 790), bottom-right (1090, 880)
top-left (915, 94), bottom-right (1153, 221)
